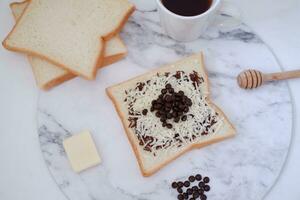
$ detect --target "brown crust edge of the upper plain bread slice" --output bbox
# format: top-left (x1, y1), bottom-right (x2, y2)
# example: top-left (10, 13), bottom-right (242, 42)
top-left (2, 0), bottom-right (135, 80)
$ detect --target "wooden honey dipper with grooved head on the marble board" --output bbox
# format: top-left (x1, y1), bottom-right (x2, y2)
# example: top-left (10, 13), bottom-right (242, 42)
top-left (237, 69), bottom-right (300, 89)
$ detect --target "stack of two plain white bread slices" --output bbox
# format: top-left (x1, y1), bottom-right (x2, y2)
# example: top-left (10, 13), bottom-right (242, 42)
top-left (3, 0), bottom-right (134, 90)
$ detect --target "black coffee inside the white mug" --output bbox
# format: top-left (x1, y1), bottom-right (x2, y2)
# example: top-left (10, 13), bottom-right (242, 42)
top-left (161, 0), bottom-right (212, 17)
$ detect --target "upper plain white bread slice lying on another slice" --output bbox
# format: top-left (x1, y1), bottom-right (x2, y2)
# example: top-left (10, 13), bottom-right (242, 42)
top-left (3, 0), bottom-right (134, 79)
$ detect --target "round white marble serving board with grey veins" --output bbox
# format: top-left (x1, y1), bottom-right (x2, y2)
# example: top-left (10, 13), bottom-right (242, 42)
top-left (37, 7), bottom-right (292, 200)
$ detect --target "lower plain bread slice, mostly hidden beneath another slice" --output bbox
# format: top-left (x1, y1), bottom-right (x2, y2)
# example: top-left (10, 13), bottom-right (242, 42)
top-left (10, 1), bottom-right (127, 90)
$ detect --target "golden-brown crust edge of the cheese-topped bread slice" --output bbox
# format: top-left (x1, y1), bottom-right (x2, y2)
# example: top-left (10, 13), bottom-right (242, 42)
top-left (106, 53), bottom-right (236, 177)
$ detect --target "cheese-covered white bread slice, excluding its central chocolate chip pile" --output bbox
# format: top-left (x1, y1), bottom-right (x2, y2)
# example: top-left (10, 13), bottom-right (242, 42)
top-left (106, 53), bottom-right (235, 176)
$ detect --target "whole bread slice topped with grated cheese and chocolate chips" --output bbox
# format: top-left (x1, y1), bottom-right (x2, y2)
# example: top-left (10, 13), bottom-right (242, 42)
top-left (106, 53), bottom-right (235, 176)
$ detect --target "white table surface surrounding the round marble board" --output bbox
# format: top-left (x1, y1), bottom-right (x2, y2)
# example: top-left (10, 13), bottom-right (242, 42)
top-left (0, 0), bottom-right (300, 200)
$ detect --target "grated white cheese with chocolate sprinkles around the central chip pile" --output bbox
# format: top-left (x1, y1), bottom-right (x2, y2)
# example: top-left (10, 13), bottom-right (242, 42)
top-left (125, 71), bottom-right (223, 156)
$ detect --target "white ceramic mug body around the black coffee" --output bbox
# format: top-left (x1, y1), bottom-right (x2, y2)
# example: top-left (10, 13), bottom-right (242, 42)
top-left (156, 0), bottom-right (221, 42)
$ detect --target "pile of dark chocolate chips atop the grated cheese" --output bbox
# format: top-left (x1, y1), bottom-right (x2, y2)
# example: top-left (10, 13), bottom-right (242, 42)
top-left (147, 84), bottom-right (192, 129)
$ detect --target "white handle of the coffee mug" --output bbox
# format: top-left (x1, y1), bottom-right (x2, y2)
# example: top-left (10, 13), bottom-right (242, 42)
top-left (217, 0), bottom-right (242, 29)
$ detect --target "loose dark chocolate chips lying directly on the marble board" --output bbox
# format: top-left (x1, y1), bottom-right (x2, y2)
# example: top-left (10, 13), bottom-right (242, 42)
top-left (171, 174), bottom-right (210, 200)
